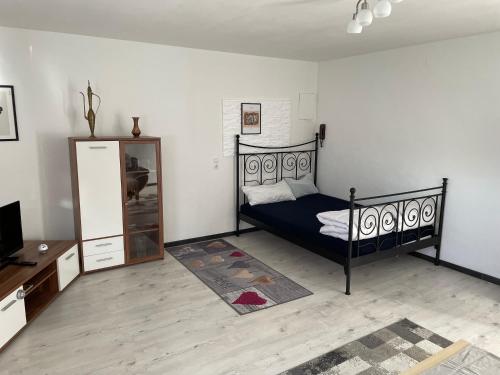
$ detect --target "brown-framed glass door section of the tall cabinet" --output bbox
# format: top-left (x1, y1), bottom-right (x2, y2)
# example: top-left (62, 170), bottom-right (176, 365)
top-left (120, 139), bottom-right (163, 264)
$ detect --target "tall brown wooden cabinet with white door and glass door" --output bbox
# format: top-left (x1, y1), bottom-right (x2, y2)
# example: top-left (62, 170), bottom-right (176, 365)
top-left (69, 137), bottom-right (163, 272)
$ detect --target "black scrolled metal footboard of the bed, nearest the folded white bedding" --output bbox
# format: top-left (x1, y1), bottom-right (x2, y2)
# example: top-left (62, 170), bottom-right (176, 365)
top-left (344, 178), bottom-right (448, 295)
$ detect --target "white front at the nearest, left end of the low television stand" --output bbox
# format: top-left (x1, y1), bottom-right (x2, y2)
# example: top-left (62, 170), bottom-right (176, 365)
top-left (0, 286), bottom-right (26, 348)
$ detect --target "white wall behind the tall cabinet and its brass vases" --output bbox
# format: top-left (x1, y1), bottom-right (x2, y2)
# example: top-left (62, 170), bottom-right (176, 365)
top-left (0, 28), bottom-right (317, 241)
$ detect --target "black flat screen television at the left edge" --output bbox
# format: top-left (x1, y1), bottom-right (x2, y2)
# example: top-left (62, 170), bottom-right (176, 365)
top-left (0, 201), bottom-right (24, 263)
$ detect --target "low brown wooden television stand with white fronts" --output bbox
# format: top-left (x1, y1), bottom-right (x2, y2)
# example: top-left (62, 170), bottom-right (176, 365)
top-left (0, 241), bottom-right (80, 352)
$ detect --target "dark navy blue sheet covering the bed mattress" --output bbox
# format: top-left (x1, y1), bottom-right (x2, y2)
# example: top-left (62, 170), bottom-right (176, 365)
top-left (241, 194), bottom-right (433, 258)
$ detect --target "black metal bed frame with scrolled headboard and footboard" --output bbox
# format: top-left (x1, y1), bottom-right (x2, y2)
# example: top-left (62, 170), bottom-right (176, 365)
top-left (235, 133), bottom-right (448, 295)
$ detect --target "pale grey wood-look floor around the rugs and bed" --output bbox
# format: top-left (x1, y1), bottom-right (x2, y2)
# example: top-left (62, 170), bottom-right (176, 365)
top-left (0, 232), bottom-right (500, 375)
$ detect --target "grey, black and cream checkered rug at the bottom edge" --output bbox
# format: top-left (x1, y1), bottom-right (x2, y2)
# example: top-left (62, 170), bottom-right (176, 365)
top-left (282, 319), bottom-right (452, 375)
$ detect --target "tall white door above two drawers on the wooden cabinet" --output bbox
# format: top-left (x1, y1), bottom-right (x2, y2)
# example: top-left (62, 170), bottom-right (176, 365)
top-left (76, 141), bottom-right (123, 240)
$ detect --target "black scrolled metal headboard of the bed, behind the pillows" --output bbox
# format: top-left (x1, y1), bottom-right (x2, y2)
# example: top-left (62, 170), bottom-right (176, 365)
top-left (235, 133), bottom-right (319, 207)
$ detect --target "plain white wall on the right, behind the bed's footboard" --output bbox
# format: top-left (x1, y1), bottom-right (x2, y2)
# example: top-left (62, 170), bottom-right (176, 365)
top-left (318, 33), bottom-right (500, 277)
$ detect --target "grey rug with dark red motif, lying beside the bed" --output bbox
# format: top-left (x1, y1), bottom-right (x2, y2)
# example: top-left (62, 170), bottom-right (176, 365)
top-left (167, 240), bottom-right (312, 315)
